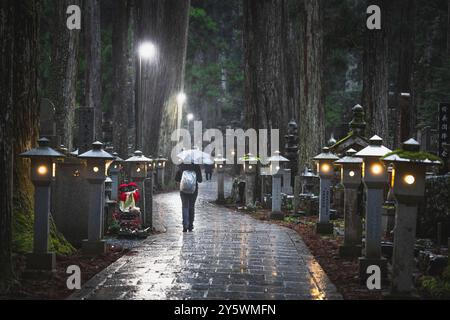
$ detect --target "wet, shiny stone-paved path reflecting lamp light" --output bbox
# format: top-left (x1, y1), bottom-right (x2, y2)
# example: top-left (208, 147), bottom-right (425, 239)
top-left (70, 181), bottom-right (341, 300)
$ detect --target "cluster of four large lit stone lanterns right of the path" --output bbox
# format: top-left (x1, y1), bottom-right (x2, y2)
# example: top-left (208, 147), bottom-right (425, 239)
top-left (314, 136), bottom-right (440, 295)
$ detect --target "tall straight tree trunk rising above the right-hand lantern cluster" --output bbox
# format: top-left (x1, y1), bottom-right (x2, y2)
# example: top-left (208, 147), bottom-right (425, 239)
top-left (362, 0), bottom-right (390, 140)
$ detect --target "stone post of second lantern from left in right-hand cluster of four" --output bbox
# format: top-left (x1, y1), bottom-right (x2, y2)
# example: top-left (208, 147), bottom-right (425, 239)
top-left (339, 187), bottom-right (362, 258)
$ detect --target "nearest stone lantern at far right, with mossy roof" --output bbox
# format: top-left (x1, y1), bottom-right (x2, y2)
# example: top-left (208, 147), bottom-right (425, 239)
top-left (383, 139), bottom-right (441, 296)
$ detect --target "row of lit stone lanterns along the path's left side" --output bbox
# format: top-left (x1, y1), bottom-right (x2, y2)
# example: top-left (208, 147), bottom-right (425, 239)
top-left (20, 138), bottom-right (171, 271)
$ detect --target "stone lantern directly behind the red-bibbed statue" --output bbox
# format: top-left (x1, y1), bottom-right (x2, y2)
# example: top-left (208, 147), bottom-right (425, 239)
top-left (125, 150), bottom-right (153, 224)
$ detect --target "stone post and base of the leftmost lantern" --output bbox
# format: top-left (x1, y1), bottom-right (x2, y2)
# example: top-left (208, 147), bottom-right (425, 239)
top-left (27, 184), bottom-right (56, 271)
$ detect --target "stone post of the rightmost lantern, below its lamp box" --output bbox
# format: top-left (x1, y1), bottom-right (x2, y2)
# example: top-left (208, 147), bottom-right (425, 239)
top-left (392, 202), bottom-right (417, 293)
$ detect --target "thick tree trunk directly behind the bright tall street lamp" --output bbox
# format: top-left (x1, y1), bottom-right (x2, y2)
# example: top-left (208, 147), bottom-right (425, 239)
top-left (136, 0), bottom-right (190, 160)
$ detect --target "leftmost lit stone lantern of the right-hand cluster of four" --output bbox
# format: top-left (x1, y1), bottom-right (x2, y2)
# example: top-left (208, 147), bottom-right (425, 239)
top-left (313, 147), bottom-right (339, 234)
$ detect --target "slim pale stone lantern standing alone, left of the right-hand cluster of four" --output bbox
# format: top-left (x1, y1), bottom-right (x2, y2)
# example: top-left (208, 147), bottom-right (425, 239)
top-left (268, 151), bottom-right (289, 220)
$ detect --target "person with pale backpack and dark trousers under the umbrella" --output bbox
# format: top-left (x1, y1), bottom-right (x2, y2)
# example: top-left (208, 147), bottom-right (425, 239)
top-left (175, 163), bottom-right (203, 232)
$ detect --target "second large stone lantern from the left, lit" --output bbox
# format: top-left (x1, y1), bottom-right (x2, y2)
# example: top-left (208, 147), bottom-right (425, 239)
top-left (78, 141), bottom-right (114, 256)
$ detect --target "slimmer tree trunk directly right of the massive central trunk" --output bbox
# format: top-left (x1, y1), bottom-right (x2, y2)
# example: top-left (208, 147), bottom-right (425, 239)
top-left (299, 0), bottom-right (325, 171)
